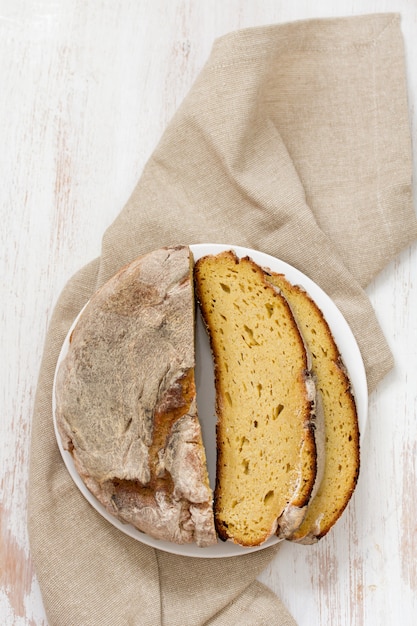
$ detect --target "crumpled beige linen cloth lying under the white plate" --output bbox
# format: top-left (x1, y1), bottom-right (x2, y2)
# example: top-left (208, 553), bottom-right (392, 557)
top-left (29, 14), bottom-right (417, 626)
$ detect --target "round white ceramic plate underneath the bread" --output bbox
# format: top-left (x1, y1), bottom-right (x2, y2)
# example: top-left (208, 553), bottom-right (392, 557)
top-left (53, 244), bottom-right (368, 558)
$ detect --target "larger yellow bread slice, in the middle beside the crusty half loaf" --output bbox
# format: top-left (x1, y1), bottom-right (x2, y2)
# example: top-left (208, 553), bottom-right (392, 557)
top-left (194, 251), bottom-right (316, 546)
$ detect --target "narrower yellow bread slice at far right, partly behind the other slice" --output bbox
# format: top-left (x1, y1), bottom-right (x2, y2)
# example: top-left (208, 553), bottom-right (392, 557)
top-left (268, 274), bottom-right (359, 544)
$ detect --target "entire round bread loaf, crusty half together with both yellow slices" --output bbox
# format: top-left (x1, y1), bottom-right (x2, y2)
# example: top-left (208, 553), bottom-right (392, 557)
top-left (55, 241), bottom-right (359, 547)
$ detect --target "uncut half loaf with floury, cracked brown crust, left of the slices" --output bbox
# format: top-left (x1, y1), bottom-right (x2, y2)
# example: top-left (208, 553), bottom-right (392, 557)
top-left (56, 246), bottom-right (217, 546)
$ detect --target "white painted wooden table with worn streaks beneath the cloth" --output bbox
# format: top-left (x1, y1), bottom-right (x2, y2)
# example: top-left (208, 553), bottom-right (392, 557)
top-left (0, 0), bottom-right (417, 626)
